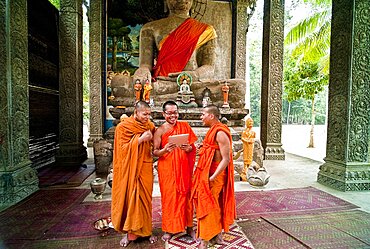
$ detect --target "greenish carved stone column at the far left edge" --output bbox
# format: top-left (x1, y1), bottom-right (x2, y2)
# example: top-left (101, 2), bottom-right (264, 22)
top-left (0, 0), bottom-right (38, 209)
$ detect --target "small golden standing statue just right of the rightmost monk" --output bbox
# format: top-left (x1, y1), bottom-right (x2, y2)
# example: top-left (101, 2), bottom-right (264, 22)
top-left (240, 117), bottom-right (256, 181)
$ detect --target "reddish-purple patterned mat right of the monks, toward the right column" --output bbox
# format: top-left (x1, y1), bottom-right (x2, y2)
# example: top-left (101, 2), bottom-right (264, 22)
top-left (235, 187), bottom-right (358, 218)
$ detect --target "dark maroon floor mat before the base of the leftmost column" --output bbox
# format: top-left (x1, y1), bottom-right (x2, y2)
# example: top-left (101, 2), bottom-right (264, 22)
top-left (0, 189), bottom-right (90, 241)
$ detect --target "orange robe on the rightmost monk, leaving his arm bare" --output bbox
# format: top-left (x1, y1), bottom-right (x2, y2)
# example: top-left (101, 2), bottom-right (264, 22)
top-left (191, 122), bottom-right (236, 240)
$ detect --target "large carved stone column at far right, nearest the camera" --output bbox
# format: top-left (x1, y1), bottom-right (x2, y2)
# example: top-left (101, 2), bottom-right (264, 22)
top-left (317, 0), bottom-right (370, 191)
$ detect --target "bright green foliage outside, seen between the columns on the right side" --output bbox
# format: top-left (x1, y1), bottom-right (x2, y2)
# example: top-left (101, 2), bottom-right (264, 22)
top-left (247, 0), bottom-right (331, 135)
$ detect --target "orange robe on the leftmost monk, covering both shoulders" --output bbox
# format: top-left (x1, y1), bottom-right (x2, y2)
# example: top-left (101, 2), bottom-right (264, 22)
top-left (111, 116), bottom-right (155, 239)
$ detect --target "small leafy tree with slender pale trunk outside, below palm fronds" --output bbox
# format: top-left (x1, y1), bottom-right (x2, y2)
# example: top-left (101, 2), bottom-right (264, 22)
top-left (283, 56), bottom-right (328, 148)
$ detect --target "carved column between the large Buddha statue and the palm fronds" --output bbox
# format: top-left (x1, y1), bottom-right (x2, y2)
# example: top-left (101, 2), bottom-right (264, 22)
top-left (261, 0), bottom-right (285, 160)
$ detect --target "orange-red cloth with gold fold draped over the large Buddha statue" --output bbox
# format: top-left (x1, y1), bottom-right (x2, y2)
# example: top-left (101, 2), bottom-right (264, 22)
top-left (153, 18), bottom-right (216, 79)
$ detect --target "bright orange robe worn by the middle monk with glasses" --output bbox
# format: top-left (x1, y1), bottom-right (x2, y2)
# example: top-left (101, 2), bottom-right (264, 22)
top-left (158, 121), bottom-right (197, 233)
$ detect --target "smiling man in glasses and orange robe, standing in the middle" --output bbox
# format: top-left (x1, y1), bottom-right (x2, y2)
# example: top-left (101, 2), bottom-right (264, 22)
top-left (153, 101), bottom-right (197, 241)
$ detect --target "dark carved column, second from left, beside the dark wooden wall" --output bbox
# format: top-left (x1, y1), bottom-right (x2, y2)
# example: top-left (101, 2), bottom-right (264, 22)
top-left (57, 0), bottom-right (87, 166)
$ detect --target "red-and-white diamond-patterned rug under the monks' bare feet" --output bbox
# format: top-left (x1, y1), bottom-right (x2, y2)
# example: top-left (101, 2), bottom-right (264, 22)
top-left (166, 223), bottom-right (254, 249)
